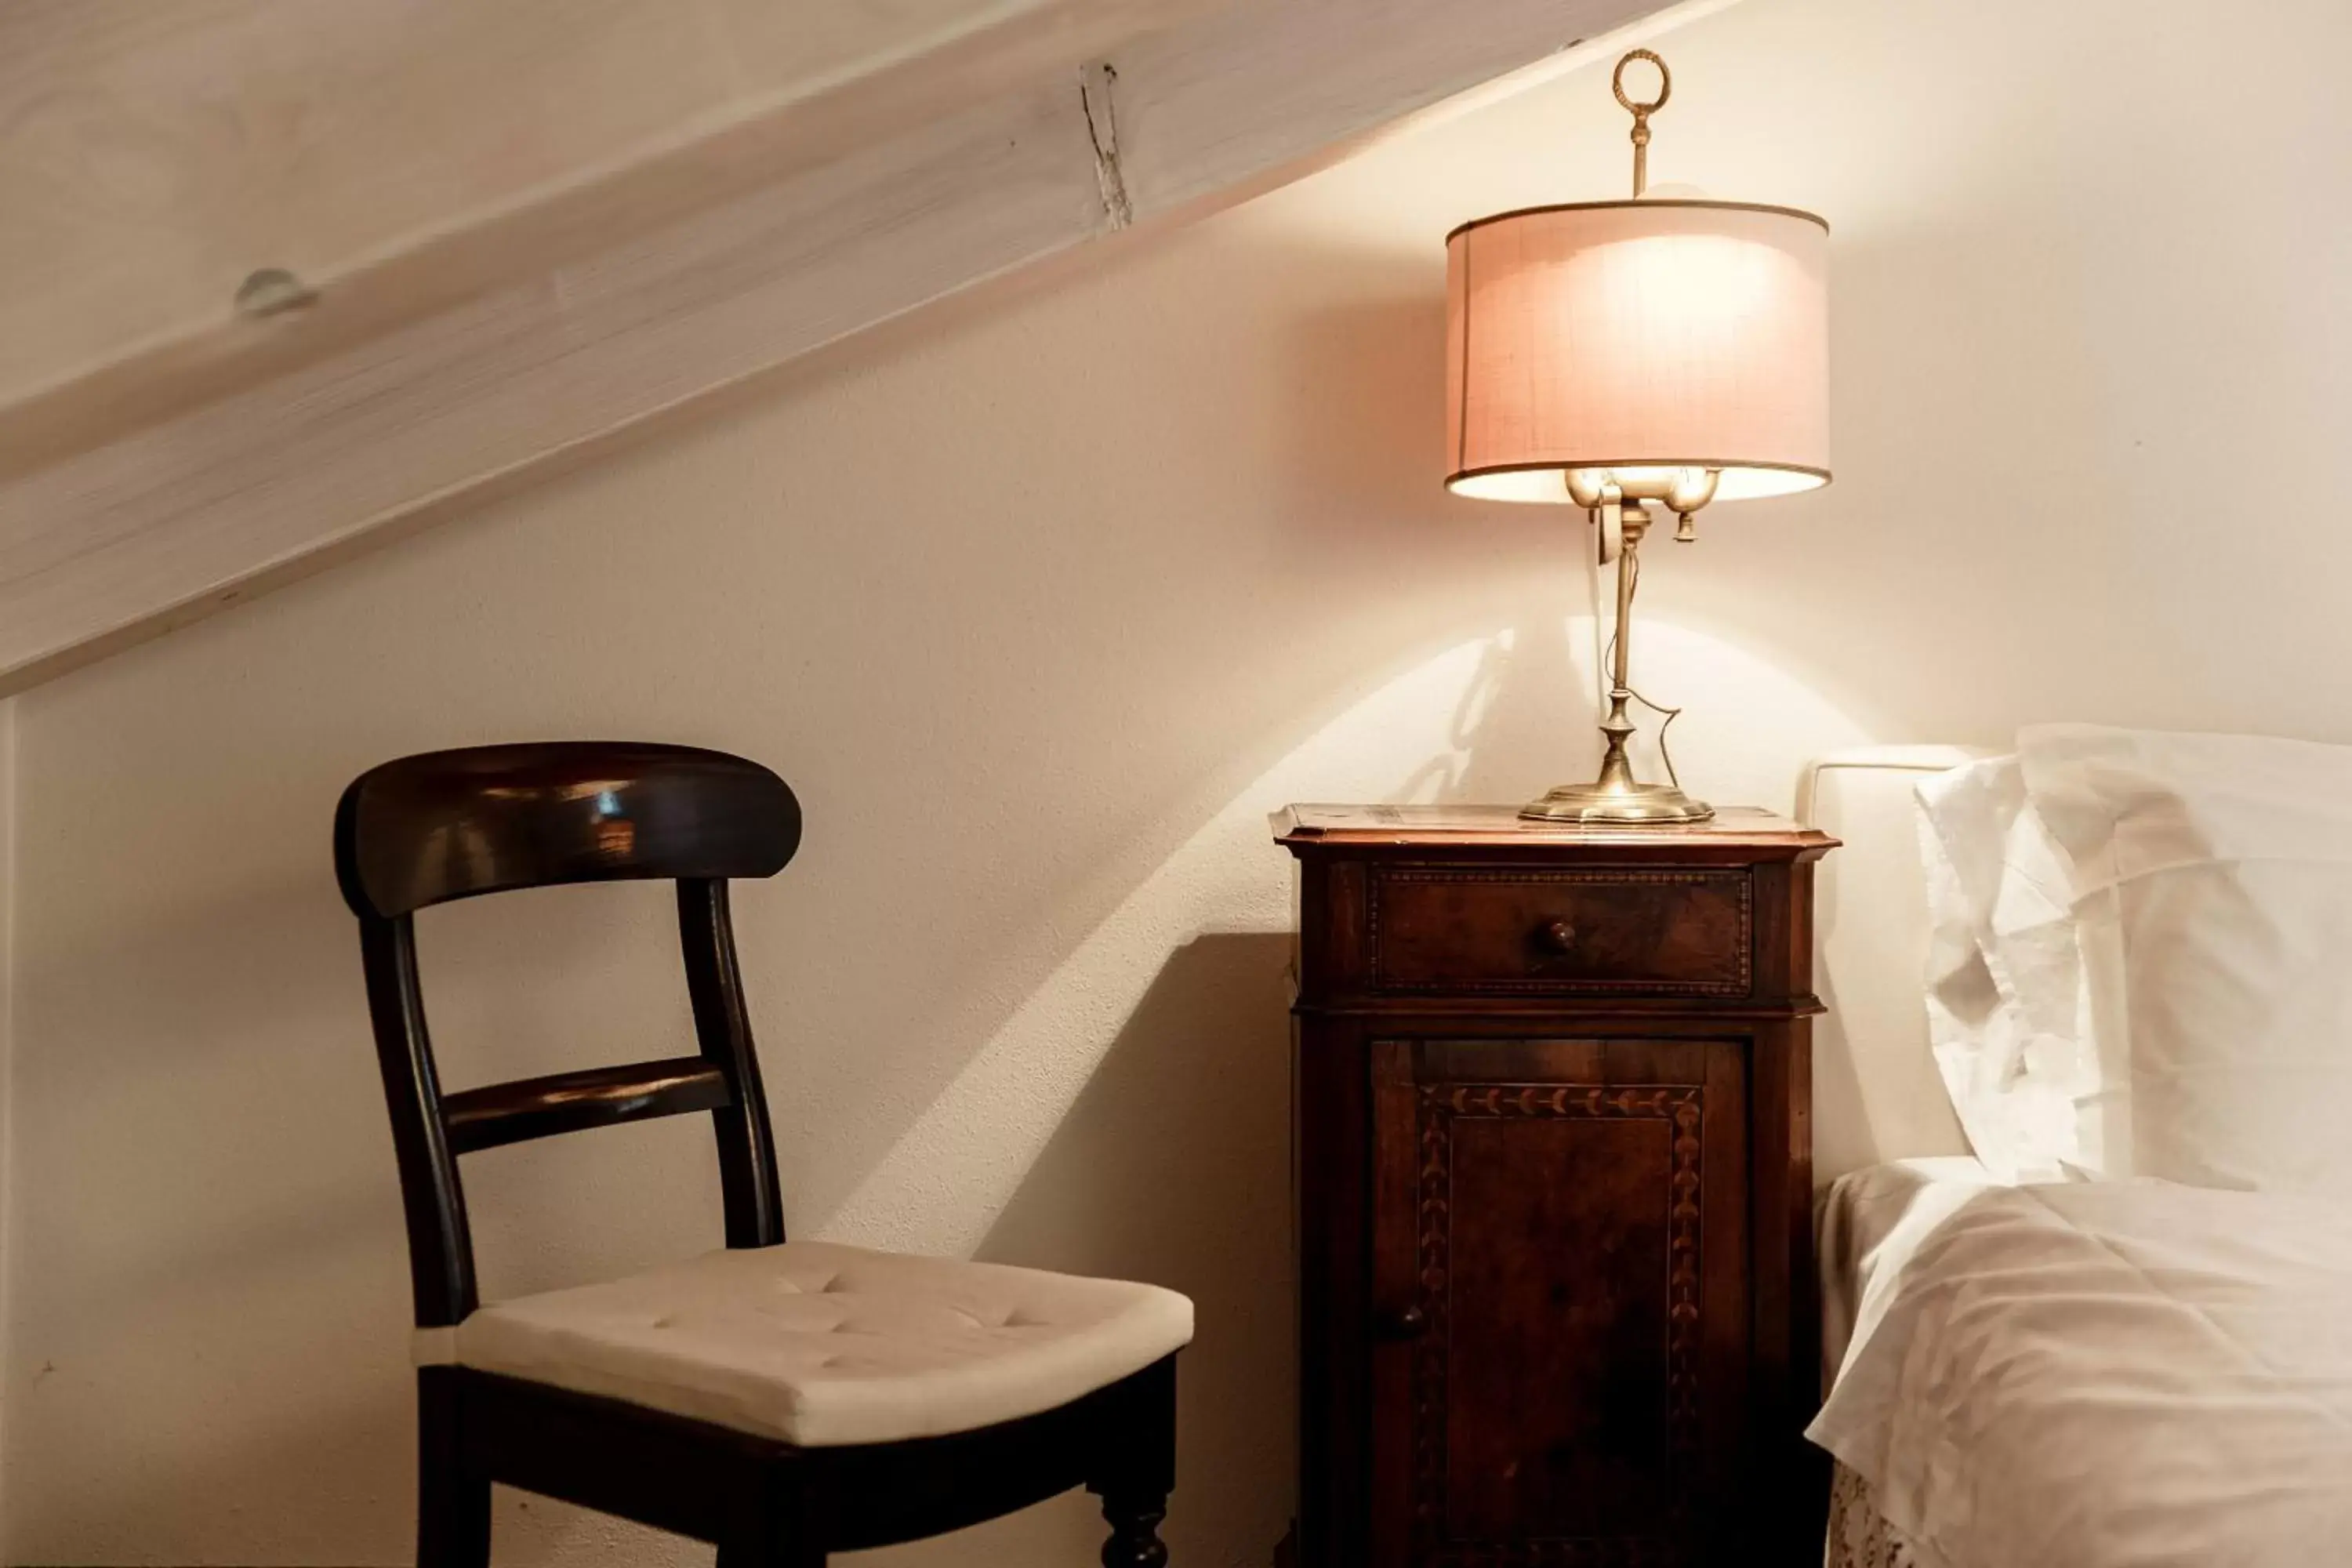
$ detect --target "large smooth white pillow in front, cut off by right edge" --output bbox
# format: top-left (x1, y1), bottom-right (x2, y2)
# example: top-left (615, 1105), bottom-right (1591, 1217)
top-left (2018, 724), bottom-right (2352, 1194)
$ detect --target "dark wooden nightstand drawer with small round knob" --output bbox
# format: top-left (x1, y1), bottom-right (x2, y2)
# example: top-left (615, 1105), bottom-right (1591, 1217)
top-left (1367, 865), bottom-right (1755, 996)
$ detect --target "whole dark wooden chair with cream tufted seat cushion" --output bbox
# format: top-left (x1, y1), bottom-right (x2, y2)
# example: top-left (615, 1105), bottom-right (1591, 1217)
top-left (334, 743), bottom-right (1192, 1568)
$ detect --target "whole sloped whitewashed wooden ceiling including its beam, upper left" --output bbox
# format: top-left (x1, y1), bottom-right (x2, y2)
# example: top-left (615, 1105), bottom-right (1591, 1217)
top-left (0, 0), bottom-right (1729, 691)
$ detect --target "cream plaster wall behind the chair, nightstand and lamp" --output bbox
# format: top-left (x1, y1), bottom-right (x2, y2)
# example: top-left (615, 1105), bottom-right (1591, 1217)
top-left (0, 0), bottom-right (2352, 1568)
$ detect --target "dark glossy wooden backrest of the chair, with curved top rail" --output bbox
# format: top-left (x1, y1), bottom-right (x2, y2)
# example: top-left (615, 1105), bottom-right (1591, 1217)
top-left (334, 741), bottom-right (800, 1328)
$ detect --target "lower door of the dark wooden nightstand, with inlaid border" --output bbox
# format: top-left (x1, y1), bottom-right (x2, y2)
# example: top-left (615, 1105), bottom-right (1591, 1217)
top-left (1371, 1039), bottom-right (1748, 1568)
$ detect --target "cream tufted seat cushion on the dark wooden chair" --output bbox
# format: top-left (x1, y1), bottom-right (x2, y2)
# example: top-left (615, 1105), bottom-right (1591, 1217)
top-left (419, 1241), bottom-right (1192, 1448)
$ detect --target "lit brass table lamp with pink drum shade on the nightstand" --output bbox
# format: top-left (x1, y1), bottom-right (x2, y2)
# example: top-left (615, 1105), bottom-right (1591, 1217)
top-left (1446, 49), bottom-right (1830, 822)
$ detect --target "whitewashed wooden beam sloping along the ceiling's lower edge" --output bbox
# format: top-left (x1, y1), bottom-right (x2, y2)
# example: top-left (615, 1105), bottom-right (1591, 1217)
top-left (0, 0), bottom-right (1726, 691)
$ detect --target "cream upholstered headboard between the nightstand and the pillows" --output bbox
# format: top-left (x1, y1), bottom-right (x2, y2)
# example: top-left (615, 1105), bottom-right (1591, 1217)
top-left (1797, 746), bottom-right (1985, 1182)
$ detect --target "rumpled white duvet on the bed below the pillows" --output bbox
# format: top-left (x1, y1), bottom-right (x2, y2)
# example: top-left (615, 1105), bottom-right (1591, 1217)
top-left (1811, 1173), bottom-right (2352, 1568)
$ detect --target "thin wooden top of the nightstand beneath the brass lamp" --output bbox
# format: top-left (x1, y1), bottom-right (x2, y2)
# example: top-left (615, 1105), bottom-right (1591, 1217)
top-left (1270, 806), bottom-right (1837, 853)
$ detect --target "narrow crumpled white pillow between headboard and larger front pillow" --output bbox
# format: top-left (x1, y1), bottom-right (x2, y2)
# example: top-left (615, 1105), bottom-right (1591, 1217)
top-left (1917, 757), bottom-right (2131, 1182)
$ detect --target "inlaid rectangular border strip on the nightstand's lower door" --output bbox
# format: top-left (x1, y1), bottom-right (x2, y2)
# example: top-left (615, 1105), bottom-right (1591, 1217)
top-left (1411, 1083), bottom-right (1705, 1568)
